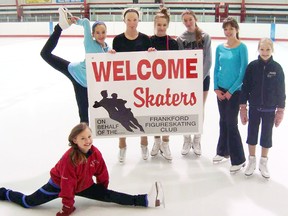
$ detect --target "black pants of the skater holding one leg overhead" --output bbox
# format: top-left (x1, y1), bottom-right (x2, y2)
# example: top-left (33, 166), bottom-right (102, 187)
top-left (40, 24), bottom-right (88, 123)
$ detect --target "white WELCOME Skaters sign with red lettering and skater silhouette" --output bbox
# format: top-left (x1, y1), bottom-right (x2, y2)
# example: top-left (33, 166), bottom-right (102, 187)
top-left (86, 50), bottom-right (203, 138)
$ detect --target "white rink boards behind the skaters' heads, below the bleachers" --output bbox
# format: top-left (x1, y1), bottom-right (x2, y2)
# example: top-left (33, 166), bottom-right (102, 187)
top-left (0, 22), bottom-right (288, 41)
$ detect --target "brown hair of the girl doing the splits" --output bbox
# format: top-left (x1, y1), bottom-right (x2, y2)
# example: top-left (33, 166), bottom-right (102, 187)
top-left (68, 122), bottom-right (90, 166)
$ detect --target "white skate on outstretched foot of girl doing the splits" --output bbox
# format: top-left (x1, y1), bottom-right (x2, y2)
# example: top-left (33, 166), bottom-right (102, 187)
top-left (147, 182), bottom-right (165, 207)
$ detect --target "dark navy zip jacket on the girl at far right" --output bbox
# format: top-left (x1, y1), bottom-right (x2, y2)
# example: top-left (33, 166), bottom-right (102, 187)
top-left (240, 56), bottom-right (286, 109)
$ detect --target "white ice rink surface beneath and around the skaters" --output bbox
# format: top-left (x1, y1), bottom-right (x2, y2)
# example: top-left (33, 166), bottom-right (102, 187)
top-left (0, 38), bottom-right (288, 216)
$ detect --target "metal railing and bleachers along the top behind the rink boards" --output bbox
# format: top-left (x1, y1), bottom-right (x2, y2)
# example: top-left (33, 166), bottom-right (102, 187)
top-left (0, 2), bottom-right (288, 23)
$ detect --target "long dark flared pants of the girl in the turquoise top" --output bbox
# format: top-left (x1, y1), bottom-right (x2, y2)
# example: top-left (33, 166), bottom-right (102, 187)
top-left (217, 91), bottom-right (246, 165)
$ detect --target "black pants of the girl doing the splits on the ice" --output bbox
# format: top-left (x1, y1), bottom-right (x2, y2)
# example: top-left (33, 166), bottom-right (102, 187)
top-left (6, 179), bottom-right (147, 208)
